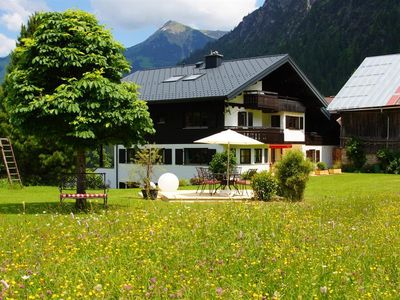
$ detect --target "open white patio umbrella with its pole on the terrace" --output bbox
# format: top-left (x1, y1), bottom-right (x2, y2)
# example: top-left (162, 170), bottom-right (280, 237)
top-left (194, 129), bottom-right (264, 184)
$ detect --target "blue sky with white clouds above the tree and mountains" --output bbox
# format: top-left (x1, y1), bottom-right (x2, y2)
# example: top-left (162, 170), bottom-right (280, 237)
top-left (0, 0), bottom-right (264, 57)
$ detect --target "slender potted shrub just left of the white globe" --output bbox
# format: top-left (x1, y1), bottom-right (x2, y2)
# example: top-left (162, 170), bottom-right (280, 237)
top-left (135, 146), bottom-right (162, 200)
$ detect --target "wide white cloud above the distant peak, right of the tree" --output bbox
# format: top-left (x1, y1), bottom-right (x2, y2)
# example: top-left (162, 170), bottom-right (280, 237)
top-left (91, 0), bottom-right (257, 30)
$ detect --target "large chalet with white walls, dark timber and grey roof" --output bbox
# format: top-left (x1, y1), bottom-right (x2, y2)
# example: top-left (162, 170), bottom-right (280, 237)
top-left (100, 52), bottom-right (339, 187)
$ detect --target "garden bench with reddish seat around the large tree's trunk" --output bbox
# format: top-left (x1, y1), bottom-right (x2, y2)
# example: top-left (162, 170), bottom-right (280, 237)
top-left (59, 173), bottom-right (108, 207)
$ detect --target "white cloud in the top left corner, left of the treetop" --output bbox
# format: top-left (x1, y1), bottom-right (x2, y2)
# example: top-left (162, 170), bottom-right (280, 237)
top-left (0, 0), bottom-right (48, 32)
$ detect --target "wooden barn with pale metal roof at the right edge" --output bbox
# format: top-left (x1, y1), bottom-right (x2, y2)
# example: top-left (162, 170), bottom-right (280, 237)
top-left (328, 54), bottom-right (400, 162)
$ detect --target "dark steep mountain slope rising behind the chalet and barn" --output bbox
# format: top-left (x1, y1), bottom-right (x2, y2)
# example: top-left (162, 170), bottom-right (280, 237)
top-left (186, 0), bottom-right (400, 95)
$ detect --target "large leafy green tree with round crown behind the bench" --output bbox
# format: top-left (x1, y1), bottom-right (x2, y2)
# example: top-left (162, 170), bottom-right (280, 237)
top-left (4, 10), bottom-right (154, 207)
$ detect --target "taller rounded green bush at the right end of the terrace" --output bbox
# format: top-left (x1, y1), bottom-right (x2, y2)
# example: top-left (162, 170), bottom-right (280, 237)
top-left (275, 150), bottom-right (313, 201)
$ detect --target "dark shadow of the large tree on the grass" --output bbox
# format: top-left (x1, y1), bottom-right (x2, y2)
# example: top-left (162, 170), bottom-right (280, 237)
top-left (0, 202), bottom-right (123, 215)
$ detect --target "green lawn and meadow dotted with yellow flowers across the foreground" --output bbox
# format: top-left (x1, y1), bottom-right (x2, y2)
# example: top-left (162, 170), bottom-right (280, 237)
top-left (0, 174), bottom-right (400, 299)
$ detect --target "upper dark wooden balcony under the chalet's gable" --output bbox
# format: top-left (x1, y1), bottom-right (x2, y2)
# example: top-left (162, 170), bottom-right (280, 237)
top-left (243, 91), bottom-right (306, 113)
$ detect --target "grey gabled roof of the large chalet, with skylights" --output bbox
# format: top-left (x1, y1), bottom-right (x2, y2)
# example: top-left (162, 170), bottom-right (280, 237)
top-left (124, 54), bottom-right (291, 101)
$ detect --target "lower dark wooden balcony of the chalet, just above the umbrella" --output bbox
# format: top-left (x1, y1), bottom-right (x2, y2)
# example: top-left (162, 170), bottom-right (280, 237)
top-left (226, 127), bottom-right (284, 144)
